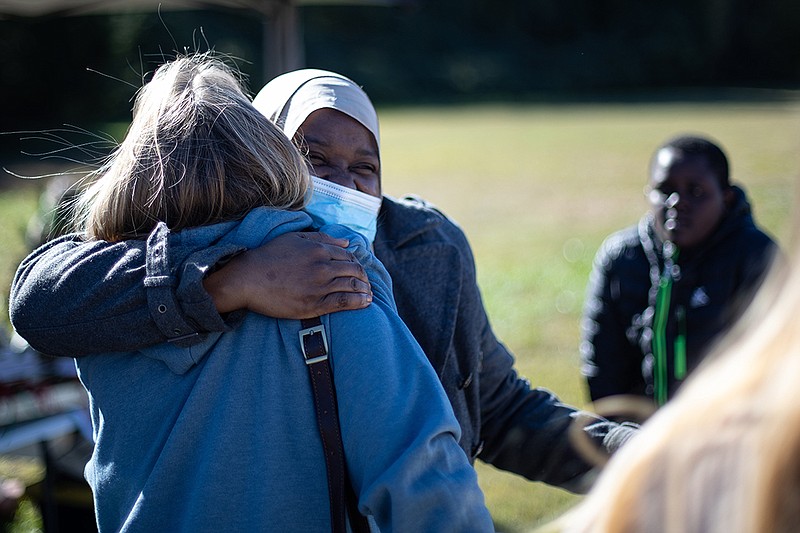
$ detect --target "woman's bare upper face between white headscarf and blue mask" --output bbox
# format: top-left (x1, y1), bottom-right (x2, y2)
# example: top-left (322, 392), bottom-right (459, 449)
top-left (295, 108), bottom-right (381, 198)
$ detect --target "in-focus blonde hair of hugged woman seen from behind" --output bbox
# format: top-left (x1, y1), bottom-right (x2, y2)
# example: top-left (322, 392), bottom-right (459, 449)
top-left (77, 53), bottom-right (309, 241)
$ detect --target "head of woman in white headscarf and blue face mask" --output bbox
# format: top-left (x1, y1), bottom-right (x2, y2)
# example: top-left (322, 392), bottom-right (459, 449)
top-left (253, 69), bottom-right (381, 242)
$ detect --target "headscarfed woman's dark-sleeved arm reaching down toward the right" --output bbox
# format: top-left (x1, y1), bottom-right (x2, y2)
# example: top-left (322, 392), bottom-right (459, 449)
top-left (434, 218), bottom-right (635, 492)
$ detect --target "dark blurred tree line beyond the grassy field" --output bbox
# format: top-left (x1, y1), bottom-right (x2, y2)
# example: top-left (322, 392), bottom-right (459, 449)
top-left (0, 0), bottom-right (800, 135)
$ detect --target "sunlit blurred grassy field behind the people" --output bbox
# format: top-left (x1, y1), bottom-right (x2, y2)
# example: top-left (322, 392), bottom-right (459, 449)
top-left (0, 93), bottom-right (800, 532)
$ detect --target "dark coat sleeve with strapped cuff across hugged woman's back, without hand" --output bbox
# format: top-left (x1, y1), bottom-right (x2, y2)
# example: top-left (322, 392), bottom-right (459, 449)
top-left (9, 224), bottom-right (241, 357)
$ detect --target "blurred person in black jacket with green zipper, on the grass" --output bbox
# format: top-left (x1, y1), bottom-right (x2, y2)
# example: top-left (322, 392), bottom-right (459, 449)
top-left (581, 135), bottom-right (777, 405)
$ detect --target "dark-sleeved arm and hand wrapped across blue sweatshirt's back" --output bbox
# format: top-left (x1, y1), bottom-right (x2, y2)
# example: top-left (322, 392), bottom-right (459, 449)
top-left (9, 222), bottom-right (371, 357)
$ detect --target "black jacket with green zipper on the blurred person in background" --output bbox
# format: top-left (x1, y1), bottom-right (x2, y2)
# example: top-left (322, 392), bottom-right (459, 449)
top-left (581, 187), bottom-right (777, 400)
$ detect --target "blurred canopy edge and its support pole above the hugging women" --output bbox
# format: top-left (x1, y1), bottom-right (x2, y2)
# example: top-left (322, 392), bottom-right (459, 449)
top-left (0, 0), bottom-right (406, 79)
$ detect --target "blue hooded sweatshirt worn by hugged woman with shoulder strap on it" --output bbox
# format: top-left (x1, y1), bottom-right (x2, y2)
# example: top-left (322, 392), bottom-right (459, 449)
top-left (77, 208), bottom-right (493, 533)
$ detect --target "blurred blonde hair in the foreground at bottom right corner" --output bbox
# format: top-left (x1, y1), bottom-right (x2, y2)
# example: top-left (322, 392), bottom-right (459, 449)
top-left (554, 218), bottom-right (800, 533)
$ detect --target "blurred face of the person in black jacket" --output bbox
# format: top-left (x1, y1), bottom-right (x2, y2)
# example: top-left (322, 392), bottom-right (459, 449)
top-left (648, 147), bottom-right (732, 249)
